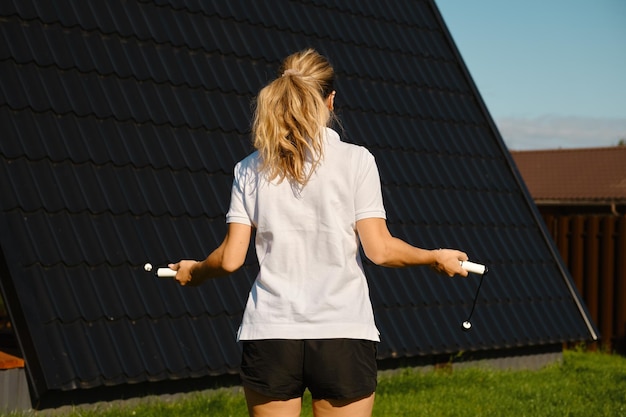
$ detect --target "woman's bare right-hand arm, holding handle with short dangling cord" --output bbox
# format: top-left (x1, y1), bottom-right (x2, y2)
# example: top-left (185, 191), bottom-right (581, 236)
top-left (356, 214), bottom-right (468, 277)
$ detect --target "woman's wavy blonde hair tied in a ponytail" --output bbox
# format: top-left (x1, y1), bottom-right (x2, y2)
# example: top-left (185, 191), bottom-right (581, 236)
top-left (252, 49), bottom-right (334, 185)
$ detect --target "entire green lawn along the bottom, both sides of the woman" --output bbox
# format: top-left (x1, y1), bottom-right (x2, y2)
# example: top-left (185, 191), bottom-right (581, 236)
top-left (10, 351), bottom-right (626, 417)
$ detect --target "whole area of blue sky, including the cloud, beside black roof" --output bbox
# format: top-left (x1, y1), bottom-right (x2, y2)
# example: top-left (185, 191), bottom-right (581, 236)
top-left (435, 0), bottom-right (626, 150)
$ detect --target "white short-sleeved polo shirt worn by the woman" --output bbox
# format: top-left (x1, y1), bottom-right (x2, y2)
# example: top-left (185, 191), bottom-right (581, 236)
top-left (226, 128), bottom-right (386, 341)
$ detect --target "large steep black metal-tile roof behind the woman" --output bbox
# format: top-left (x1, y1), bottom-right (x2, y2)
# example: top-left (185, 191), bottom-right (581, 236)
top-left (0, 0), bottom-right (595, 404)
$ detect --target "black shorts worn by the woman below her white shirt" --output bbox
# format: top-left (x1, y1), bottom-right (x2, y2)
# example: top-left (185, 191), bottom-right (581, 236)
top-left (240, 339), bottom-right (377, 400)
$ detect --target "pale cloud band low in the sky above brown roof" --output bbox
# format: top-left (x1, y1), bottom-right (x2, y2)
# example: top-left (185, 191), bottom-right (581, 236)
top-left (496, 115), bottom-right (626, 150)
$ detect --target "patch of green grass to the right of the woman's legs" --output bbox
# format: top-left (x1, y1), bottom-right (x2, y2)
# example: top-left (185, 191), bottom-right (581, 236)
top-left (374, 351), bottom-right (626, 417)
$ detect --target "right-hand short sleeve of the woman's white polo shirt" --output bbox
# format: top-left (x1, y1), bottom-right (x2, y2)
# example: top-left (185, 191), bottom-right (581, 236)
top-left (354, 148), bottom-right (387, 221)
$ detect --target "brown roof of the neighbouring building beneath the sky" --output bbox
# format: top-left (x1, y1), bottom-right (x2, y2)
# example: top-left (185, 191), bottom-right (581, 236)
top-left (511, 146), bottom-right (626, 201)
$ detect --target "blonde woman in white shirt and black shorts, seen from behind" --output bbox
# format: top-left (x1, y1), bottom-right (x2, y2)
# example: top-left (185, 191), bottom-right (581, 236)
top-left (170, 49), bottom-right (467, 417)
